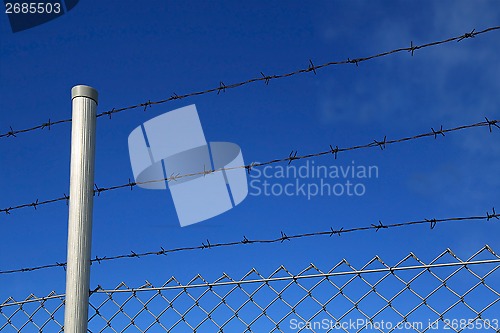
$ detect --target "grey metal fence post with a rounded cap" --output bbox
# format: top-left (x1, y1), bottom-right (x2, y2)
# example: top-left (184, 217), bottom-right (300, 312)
top-left (64, 85), bottom-right (97, 333)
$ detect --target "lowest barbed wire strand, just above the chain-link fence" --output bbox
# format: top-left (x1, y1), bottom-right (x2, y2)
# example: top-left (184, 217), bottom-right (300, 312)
top-left (0, 207), bottom-right (500, 275)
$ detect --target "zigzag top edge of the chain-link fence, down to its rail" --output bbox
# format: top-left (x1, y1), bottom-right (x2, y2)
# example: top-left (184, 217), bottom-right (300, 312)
top-left (0, 245), bottom-right (500, 308)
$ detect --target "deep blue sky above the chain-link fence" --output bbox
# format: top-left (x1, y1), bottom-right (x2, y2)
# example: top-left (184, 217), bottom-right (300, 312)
top-left (0, 1), bottom-right (500, 330)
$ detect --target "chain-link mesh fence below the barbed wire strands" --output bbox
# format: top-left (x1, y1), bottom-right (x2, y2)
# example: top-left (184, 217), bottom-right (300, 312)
top-left (0, 246), bottom-right (500, 333)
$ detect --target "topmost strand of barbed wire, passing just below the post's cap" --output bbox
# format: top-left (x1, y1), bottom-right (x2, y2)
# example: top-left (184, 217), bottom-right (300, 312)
top-left (0, 26), bottom-right (500, 138)
